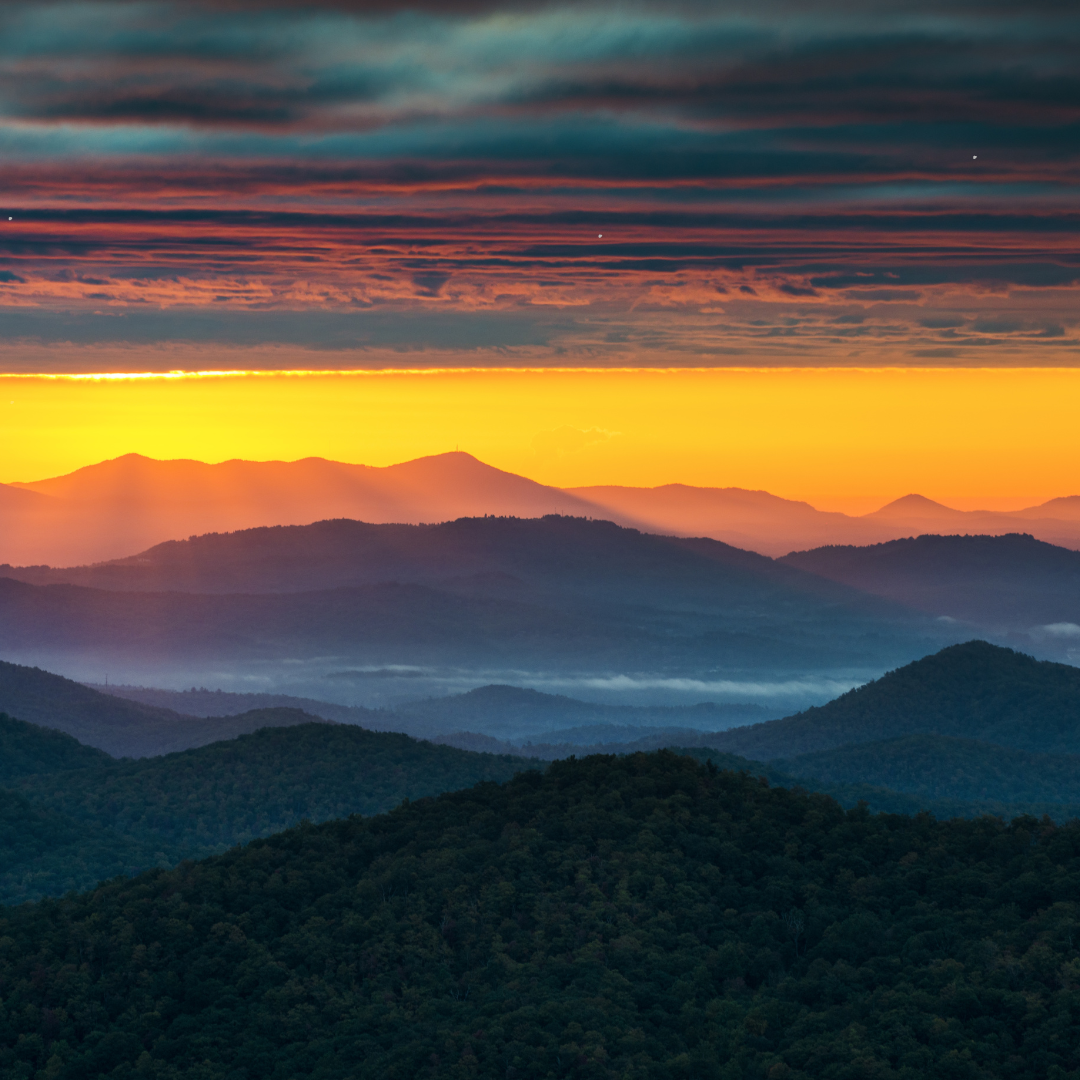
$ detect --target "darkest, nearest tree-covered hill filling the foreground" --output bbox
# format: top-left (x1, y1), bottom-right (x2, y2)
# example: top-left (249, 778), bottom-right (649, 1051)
top-left (0, 753), bottom-right (1080, 1080)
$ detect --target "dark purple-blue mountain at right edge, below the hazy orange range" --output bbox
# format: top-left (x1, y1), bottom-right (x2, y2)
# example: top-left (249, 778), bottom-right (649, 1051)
top-left (782, 534), bottom-right (1080, 637)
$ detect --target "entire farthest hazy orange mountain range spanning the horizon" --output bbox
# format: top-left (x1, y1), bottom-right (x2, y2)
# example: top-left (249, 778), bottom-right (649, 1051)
top-left (0, 451), bottom-right (1080, 566)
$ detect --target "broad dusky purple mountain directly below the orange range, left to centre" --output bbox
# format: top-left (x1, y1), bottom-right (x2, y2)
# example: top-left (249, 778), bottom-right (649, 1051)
top-left (0, 516), bottom-right (894, 606)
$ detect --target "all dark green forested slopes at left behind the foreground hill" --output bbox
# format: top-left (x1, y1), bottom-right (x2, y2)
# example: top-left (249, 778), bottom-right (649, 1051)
top-left (0, 710), bottom-right (530, 903)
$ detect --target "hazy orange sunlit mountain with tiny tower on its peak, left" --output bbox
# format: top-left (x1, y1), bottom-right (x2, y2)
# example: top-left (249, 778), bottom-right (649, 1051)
top-left (0, 453), bottom-right (597, 566)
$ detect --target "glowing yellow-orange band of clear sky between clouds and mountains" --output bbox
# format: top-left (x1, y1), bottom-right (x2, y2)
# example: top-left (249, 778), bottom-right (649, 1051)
top-left (0, 368), bottom-right (1080, 512)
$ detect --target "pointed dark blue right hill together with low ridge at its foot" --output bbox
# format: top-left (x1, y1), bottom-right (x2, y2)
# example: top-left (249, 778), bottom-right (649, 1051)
top-left (707, 642), bottom-right (1080, 818)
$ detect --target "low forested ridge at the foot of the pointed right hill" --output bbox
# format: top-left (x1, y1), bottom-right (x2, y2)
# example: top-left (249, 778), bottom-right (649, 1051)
top-left (775, 735), bottom-right (1080, 802)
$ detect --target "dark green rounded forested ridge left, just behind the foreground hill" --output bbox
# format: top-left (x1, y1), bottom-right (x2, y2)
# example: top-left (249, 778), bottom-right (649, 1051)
top-left (21, 724), bottom-right (526, 861)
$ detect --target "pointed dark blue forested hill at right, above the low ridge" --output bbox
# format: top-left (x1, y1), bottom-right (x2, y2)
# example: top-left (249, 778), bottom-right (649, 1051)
top-left (712, 642), bottom-right (1080, 760)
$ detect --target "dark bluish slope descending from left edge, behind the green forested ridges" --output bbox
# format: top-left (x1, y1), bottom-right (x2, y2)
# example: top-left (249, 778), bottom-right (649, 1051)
top-left (0, 661), bottom-right (332, 757)
